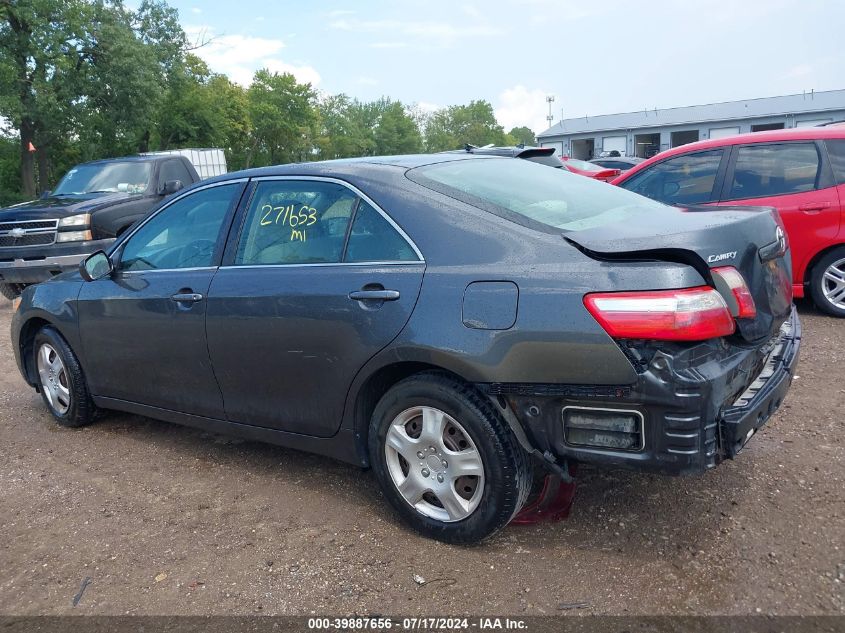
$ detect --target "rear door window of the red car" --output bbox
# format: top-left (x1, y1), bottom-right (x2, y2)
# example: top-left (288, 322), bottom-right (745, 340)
top-left (726, 143), bottom-right (820, 200)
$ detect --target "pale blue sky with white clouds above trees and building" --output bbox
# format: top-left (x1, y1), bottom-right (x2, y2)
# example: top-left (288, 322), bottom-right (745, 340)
top-left (170, 0), bottom-right (845, 132)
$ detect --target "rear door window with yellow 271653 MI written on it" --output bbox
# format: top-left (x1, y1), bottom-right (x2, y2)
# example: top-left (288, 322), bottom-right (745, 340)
top-left (235, 180), bottom-right (358, 265)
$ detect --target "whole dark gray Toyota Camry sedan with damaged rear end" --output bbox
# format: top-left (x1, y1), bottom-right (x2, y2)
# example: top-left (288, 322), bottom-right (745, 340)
top-left (12, 155), bottom-right (800, 543)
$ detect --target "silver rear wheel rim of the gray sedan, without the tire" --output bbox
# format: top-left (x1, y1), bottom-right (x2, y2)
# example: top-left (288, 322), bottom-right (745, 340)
top-left (384, 406), bottom-right (484, 523)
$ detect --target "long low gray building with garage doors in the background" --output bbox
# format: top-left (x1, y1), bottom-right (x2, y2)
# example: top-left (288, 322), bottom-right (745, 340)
top-left (537, 90), bottom-right (845, 160)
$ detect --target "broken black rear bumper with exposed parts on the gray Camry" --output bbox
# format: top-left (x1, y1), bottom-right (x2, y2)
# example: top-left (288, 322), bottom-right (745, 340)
top-left (479, 308), bottom-right (801, 474)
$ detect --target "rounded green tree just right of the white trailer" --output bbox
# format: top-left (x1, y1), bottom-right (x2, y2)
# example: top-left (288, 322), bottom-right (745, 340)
top-left (246, 69), bottom-right (319, 167)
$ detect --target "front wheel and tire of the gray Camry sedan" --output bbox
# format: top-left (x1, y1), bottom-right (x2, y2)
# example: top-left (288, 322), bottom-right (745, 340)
top-left (32, 326), bottom-right (97, 427)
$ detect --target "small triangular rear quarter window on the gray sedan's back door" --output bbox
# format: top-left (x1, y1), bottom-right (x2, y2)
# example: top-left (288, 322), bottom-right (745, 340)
top-left (344, 200), bottom-right (419, 262)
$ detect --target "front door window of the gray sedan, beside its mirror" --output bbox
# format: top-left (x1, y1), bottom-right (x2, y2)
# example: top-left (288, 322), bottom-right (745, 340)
top-left (120, 183), bottom-right (241, 270)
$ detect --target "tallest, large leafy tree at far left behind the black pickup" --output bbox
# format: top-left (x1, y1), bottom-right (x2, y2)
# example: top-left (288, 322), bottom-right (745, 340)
top-left (0, 0), bottom-right (185, 197)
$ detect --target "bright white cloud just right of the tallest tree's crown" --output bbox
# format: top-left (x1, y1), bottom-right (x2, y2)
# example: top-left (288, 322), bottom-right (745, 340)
top-left (185, 26), bottom-right (320, 86)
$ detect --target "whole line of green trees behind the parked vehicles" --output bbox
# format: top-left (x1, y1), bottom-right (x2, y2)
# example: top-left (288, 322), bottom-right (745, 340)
top-left (0, 0), bottom-right (534, 204)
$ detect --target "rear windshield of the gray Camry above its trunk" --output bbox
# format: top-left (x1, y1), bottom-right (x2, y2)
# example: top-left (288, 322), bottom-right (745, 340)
top-left (408, 158), bottom-right (665, 231)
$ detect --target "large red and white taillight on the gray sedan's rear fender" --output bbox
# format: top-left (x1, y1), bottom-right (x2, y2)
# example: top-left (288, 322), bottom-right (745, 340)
top-left (584, 286), bottom-right (736, 341)
